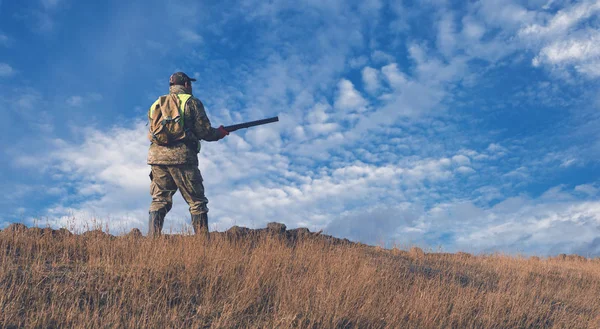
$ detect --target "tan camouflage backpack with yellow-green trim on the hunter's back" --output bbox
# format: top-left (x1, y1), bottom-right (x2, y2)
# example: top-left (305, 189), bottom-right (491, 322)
top-left (148, 94), bottom-right (192, 145)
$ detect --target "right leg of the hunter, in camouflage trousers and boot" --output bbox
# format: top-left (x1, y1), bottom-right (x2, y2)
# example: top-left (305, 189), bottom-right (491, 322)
top-left (169, 165), bottom-right (208, 236)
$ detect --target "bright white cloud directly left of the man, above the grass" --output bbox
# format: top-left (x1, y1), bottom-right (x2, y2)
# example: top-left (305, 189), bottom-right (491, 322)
top-left (17, 123), bottom-right (149, 229)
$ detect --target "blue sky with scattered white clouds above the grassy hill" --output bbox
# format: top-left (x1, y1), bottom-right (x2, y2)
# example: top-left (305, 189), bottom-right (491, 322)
top-left (0, 0), bottom-right (600, 256)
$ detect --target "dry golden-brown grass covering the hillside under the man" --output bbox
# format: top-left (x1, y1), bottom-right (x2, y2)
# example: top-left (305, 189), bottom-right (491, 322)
top-left (0, 224), bottom-right (600, 328)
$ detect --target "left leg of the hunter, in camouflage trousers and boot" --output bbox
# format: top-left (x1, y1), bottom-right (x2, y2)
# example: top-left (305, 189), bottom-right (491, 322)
top-left (148, 165), bottom-right (177, 236)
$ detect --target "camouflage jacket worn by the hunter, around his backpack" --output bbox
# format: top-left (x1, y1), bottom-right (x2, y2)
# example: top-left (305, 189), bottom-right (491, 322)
top-left (148, 85), bottom-right (220, 166)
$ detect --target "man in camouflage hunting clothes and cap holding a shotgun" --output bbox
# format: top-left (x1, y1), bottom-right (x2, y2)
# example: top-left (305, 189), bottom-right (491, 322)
top-left (148, 72), bottom-right (229, 237)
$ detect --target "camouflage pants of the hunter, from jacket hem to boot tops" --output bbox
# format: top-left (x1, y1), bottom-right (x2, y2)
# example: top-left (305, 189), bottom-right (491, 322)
top-left (150, 165), bottom-right (208, 215)
